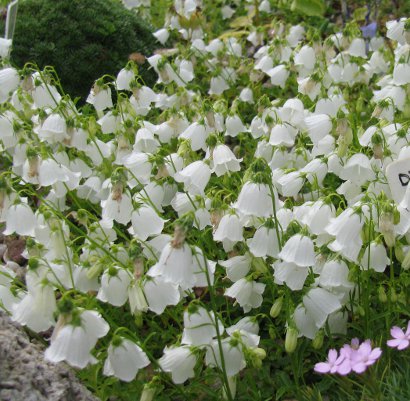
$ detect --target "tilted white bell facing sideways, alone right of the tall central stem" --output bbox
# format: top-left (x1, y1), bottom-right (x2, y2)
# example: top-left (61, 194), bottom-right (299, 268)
top-left (225, 277), bottom-right (266, 313)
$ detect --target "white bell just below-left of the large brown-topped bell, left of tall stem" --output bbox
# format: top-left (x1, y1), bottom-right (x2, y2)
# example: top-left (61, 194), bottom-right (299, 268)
top-left (144, 276), bottom-right (181, 315)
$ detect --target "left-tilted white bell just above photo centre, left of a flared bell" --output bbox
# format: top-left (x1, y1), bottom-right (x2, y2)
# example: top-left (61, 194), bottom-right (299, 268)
top-left (174, 160), bottom-right (211, 195)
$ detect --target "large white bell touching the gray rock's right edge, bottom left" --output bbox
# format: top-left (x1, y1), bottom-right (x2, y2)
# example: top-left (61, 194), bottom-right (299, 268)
top-left (44, 310), bottom-right (110, 369)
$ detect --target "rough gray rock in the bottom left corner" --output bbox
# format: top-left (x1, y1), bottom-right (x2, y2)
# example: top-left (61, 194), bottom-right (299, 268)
top-left (0, 311), bottom-right (98, 401)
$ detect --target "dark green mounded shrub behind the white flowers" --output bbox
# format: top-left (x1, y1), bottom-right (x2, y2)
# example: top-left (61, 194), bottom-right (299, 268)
top-left (11, 0), bottom-right (156, 99)
